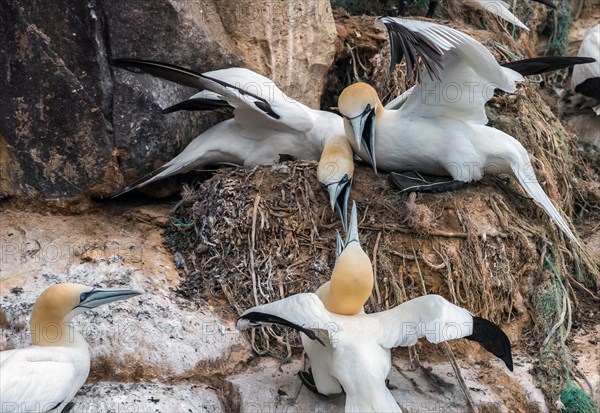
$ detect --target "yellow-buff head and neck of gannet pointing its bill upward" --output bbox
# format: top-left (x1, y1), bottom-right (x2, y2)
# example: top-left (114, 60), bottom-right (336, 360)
top-left (319, 243), bottom-right (373, 315)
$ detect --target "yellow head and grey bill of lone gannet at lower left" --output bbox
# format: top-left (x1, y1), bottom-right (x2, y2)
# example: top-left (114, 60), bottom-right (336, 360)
top-left (30, 283), bottom-right (141, 345)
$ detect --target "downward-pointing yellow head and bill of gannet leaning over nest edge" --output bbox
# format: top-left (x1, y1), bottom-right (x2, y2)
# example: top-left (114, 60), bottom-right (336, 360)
top-left (317, 137), bottom-right (354, 230)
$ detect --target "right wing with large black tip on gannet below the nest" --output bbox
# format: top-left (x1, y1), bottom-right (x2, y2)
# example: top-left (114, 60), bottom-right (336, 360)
top-left (365, 295), bottom-right (513, 370)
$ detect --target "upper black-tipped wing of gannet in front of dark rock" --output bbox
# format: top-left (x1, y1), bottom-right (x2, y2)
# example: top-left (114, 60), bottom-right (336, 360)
top-left (112, 59), bottom-right (313, 132)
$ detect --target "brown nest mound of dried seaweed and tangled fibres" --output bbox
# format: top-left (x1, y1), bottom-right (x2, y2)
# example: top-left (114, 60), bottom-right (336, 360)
top-left (167, 69), bottom-right (600, 406)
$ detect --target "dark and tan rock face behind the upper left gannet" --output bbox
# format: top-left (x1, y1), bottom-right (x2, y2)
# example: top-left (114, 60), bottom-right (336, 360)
top-left (0, 0), bottom-right (335, 199)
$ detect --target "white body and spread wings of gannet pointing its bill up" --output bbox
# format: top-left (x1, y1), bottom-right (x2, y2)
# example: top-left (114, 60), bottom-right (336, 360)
top-left (238, 293), bottom-right (512, 412)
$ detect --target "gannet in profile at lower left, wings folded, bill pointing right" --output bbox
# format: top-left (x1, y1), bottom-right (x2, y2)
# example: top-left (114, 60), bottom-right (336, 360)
top-left (0, 283), bottom-right (141, 413)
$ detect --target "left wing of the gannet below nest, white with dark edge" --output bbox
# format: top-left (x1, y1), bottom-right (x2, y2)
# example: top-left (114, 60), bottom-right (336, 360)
top-left (237, 293), bottom-right (341, 347)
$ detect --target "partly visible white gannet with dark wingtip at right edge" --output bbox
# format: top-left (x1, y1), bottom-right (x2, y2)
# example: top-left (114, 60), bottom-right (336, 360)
top-left (571, 23), bottom-right (600, 115)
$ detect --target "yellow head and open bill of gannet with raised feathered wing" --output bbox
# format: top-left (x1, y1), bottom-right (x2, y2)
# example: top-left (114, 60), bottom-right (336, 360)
top-left (338, 82), bottom-right (382, 172)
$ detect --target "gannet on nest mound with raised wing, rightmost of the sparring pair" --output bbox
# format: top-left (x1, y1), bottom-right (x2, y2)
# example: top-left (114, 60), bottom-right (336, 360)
top-left (338, 17), bottom-right (578, 243)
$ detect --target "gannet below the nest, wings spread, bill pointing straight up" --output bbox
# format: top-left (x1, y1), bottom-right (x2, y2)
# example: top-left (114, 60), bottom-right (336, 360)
top-left (237, 205), bottom-right (513, 412)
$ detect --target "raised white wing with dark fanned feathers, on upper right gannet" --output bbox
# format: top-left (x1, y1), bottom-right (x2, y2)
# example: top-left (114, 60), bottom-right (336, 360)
top-left (376, 17), bottom-right (523, 125)
